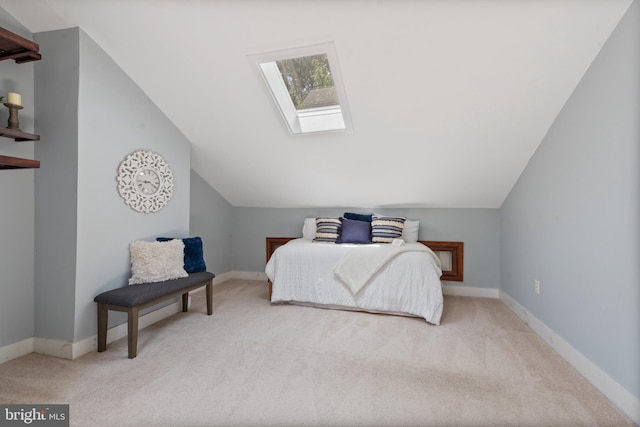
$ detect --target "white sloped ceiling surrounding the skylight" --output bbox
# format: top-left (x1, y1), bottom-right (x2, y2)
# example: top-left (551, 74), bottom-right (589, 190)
top-left (0, 0), bottom-right (632, 208)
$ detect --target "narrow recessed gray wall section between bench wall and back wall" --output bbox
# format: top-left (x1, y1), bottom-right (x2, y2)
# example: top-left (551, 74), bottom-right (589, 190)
top-left (189, 170), bottom-right (234, 275)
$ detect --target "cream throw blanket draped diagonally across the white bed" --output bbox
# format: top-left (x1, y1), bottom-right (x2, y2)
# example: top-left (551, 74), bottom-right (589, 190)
top-left (333, 243), bottom-right (440, 294)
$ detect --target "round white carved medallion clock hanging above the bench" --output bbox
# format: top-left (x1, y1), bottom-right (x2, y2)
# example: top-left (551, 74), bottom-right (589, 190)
top-left (116, 150), bottom-right (173, 213)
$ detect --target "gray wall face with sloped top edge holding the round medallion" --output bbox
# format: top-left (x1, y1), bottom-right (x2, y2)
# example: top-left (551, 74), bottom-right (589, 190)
top-left (73, 30), bottom-right (191, 341)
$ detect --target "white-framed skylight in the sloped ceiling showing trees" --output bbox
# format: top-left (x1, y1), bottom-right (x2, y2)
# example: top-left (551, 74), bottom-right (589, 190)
top-left (252, 43), bottom-right (352, 135)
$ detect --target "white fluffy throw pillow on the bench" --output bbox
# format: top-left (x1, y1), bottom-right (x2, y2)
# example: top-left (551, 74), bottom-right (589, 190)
top-left (129, 239), bottom-right (189, 285)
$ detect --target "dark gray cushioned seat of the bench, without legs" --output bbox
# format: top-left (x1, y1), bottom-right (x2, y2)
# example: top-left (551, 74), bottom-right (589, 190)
top-left (93, 271), bottom-right (215, 307)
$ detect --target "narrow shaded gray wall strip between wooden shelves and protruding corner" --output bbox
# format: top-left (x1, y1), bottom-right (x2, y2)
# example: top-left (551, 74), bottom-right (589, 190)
top-left (34, 29), bottom-right (80, 341)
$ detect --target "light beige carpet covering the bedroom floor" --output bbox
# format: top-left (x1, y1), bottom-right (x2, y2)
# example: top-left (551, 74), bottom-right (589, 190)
top-left (0, 280), bottom-right (633, 426)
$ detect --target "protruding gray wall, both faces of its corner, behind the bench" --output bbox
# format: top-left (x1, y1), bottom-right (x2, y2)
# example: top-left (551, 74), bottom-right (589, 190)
top-left (35, 28), bottom-right (190, 342)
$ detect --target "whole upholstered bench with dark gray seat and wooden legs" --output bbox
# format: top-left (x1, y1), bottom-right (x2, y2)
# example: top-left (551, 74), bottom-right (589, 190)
top-left (93, 271), bottom-right (215, 359)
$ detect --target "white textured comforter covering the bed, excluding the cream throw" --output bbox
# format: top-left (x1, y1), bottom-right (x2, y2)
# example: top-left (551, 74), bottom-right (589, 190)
top-left (265, 239), bottom-right (443, 325)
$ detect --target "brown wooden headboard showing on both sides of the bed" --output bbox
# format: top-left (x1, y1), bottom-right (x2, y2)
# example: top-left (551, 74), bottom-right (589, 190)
top-left (266, 237), bottom-right (464, 282)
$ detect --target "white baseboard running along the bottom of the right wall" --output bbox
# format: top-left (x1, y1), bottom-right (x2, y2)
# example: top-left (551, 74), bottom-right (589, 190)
top-left (499, 291), bottom-right (640, 424)
